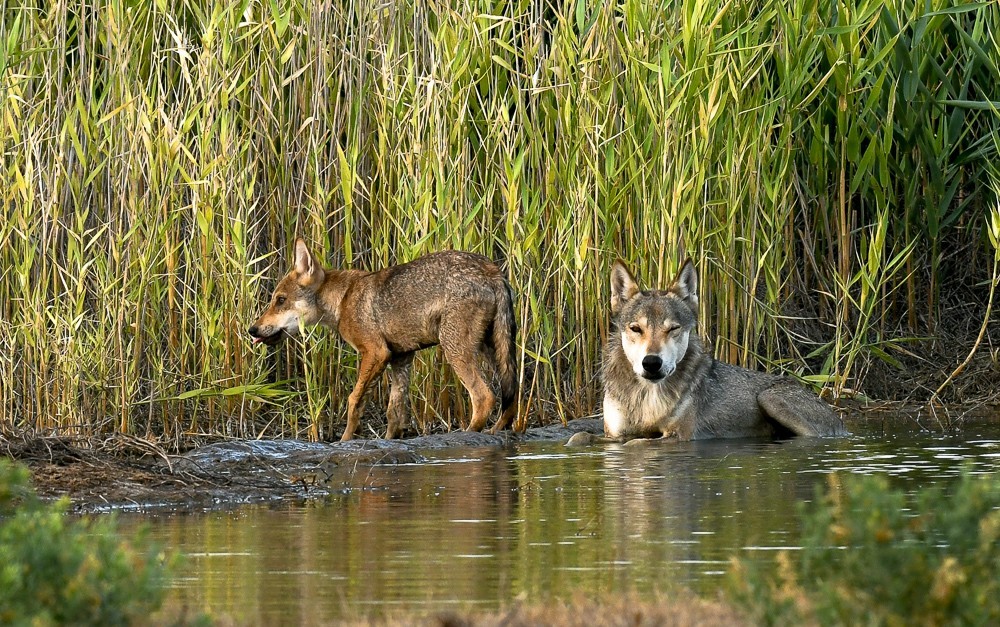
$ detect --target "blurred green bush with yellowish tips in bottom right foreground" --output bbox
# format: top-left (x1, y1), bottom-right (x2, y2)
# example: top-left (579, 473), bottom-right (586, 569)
top-left (731, 474), bottom-right (1000, 625)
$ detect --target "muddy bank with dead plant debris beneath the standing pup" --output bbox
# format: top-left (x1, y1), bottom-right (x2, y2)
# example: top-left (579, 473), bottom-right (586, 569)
top-left (7, 419), bottom-right (603, 513)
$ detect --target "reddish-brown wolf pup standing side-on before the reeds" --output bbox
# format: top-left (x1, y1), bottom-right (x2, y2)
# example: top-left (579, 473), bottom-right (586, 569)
top-left (249, 239), bottom-right (518, 440)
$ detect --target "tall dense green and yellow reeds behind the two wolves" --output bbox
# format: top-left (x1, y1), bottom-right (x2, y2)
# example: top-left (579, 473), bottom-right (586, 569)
top-left (0, 0), bottom-right (1000, 445)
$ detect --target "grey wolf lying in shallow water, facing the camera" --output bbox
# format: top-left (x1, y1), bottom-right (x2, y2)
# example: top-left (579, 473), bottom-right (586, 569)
top-left (567, 260), bottom-right (846, 445)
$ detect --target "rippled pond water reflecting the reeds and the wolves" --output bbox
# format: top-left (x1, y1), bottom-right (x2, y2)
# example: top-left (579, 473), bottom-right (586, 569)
top-left (122, 425), bottom-right (1000, 624)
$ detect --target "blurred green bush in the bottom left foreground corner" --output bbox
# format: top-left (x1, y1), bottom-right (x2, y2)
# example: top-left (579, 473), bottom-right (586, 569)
top-left (0, 459), bottom-right (169, 625)
